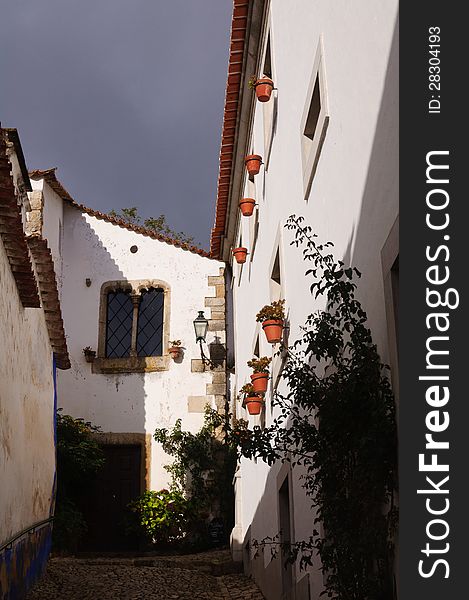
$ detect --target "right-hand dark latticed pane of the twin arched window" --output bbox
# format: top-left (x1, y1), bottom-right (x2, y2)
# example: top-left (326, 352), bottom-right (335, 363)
top-left (137, 288), bottom-right (164, 356)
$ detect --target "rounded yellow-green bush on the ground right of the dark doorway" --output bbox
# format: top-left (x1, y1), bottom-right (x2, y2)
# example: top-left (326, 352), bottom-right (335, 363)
top-left (129, 490), bottom-right (196, 547)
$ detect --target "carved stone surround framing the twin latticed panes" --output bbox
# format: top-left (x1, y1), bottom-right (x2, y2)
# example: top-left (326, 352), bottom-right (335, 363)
top-left (92, 279), bottom-right (171, 373)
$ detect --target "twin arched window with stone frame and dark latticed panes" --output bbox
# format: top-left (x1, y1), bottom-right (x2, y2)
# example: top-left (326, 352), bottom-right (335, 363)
top-left (93, 280), bottom-right (169, 372)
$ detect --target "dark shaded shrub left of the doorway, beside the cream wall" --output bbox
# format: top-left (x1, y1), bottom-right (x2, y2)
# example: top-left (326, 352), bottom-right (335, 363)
top-left (53, 408), bottom-right (104, 552)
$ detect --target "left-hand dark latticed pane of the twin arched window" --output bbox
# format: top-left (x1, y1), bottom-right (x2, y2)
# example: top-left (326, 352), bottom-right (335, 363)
top-left (106, 290), bottom-right (133, 358)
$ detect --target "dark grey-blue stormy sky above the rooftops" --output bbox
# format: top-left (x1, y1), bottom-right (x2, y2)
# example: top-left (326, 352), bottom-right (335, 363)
top-left (0, 0), bottom-right (232, 246)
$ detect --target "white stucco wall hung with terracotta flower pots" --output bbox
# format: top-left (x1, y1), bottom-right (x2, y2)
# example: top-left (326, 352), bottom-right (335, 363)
top-left (229, 0), bottom-right (398, 600)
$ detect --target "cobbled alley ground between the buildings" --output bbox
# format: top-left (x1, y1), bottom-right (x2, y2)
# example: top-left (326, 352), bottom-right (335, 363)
top-left (27, 551), bottom-right (263, 600)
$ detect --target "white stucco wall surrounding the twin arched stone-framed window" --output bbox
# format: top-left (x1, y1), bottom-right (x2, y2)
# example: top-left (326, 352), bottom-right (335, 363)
top-left (59, 206), bottom-right (225, 489)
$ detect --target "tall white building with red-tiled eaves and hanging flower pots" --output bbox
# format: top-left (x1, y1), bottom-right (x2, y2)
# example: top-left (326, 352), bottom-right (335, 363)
top-left (211, 0), bottom-right (398, 600)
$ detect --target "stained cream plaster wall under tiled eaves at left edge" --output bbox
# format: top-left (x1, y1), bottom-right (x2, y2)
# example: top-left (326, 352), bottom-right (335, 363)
top-left (0, 196), bottom-right (55, 543)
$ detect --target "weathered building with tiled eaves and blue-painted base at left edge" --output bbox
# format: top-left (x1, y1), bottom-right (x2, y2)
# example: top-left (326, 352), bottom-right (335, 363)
top-left (0, 129), bottom-right (70, 598)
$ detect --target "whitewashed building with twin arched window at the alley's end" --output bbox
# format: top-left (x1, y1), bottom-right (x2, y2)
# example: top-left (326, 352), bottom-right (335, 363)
top-left (27, 169), bottom-right (226, 550)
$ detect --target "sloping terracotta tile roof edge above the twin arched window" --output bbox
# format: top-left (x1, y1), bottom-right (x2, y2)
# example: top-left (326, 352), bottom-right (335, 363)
top-left (29, 168), bottom-right (212, 258)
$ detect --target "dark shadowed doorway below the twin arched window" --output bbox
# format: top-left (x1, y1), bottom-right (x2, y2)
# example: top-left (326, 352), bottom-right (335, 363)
top-left (80, 445), bottom-right (142, 552)
